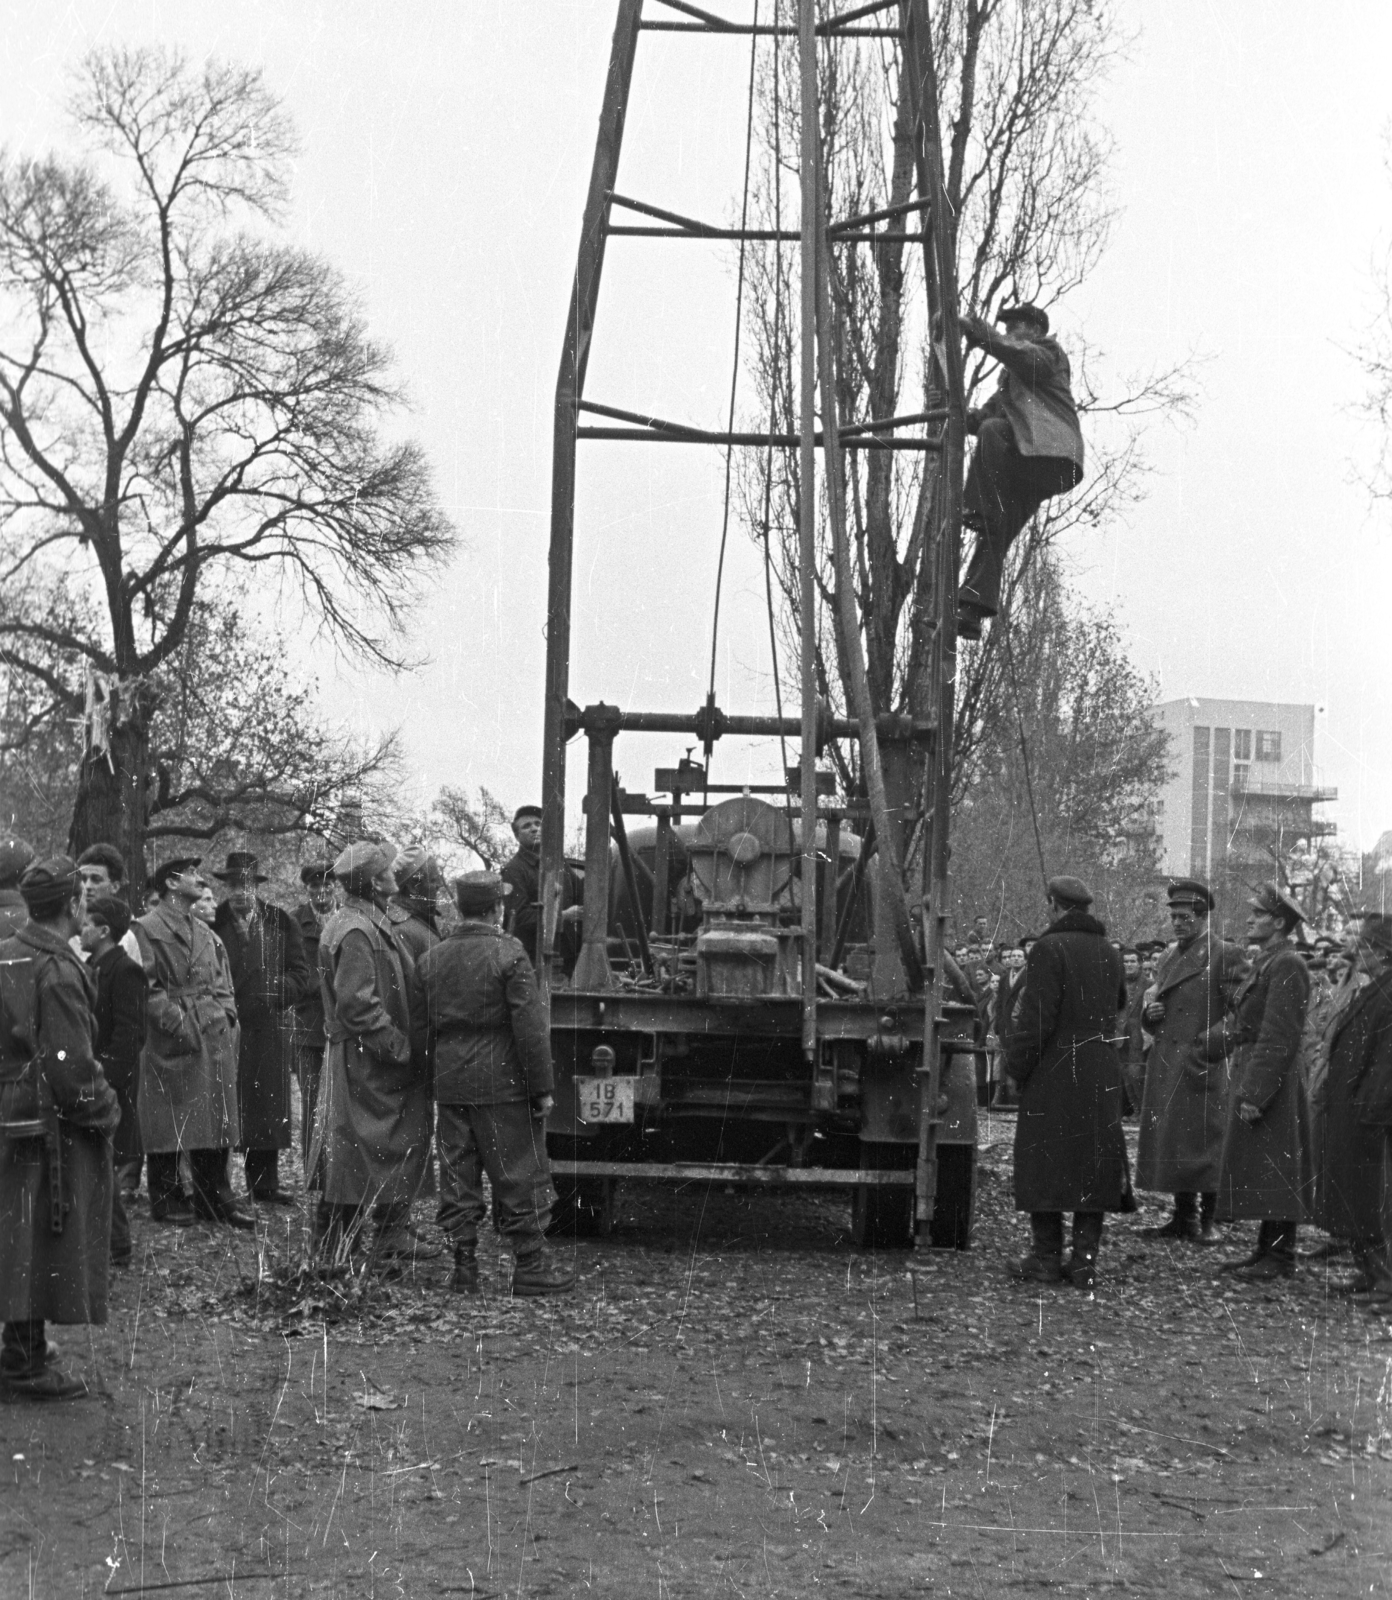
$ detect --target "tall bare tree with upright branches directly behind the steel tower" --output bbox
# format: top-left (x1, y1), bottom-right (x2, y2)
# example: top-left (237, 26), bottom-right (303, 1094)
top-left (742, 0), bottom-right (1184, 796)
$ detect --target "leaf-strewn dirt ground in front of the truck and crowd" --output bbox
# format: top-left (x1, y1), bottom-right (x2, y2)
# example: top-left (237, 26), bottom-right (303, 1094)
top-left (0, 1126), bottom-right (1392, 1600)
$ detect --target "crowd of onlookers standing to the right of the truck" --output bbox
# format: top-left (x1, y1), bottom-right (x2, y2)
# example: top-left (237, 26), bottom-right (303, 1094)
top-left (950, 878), bottom-right (1392, 1310)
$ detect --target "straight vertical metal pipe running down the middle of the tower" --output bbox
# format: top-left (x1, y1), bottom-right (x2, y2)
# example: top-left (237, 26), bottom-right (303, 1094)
top-left (797, 0), bottom-right (821, 1062)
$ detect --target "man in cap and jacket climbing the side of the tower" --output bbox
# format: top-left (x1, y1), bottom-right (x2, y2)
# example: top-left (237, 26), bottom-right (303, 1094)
top-left (957, 306), bottom-right (1083, 638)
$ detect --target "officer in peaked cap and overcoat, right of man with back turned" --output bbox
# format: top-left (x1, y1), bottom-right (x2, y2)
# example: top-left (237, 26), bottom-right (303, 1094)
top-left (1136, 878), bottom-right (1246, 1245)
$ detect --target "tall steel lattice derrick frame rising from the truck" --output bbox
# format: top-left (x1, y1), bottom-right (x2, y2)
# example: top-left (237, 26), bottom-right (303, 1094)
top-left (539, 0), bottom-right (965, 1221)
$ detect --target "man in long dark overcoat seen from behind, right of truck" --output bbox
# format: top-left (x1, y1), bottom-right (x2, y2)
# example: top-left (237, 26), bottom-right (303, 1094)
top-left (1005, 877), bottom-right (1134, 1290)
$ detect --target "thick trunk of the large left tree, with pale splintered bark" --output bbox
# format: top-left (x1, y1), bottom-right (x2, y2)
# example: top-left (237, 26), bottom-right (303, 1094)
top-left (67, 675), bottom-right (154, 912)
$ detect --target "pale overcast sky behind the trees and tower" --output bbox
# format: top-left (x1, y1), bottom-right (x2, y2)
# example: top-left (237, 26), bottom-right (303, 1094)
top-left (0, 0), bottom-right (1392, 845)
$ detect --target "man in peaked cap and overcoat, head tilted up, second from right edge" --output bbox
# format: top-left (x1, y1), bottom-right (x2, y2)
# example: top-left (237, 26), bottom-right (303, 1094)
top-left (1210, 883), bottom-right (1312, 1280)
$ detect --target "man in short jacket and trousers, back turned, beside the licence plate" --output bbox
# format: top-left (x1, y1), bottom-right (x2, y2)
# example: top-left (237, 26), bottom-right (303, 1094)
top-left (419, 872), bottom-right (574, 1294)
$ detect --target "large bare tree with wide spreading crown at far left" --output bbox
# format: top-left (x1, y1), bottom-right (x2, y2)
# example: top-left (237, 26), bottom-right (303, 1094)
top-left (0, 50), bottom-right (453, 872)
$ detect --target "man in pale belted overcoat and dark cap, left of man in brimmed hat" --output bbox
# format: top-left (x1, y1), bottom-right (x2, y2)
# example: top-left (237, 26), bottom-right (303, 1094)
top-left (131, 856), bottom-right (256, 1229)
